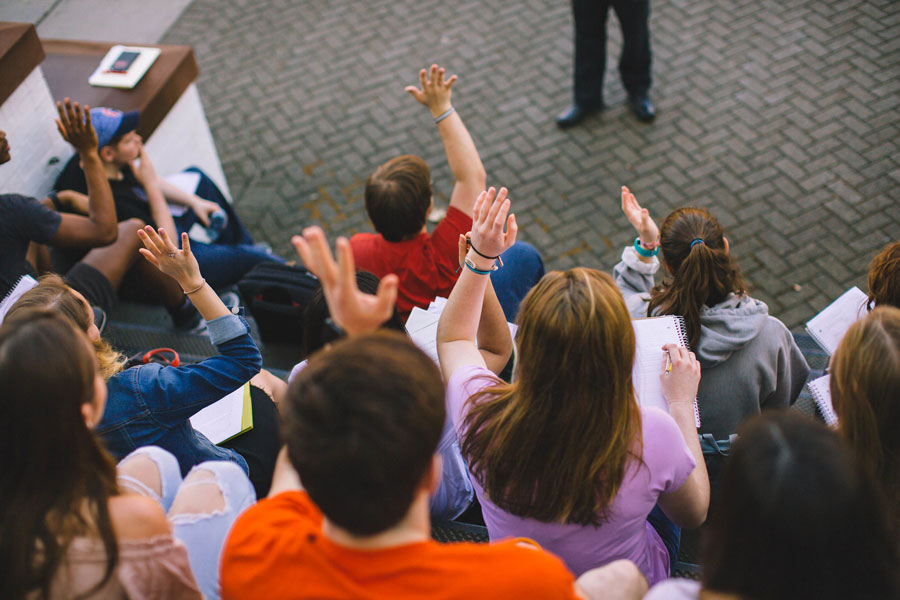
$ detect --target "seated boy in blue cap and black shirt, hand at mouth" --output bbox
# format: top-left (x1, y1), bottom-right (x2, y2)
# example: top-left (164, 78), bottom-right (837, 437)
top-left (54, 108), bottom-right (282, 290)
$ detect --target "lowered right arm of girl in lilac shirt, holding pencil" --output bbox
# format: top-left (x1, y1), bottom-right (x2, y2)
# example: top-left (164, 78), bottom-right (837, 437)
top-left (659, 344), bottom-right (709, 529)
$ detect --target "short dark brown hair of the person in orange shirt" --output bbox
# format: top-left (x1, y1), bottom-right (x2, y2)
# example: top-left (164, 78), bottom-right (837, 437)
top-left (285, 331), bottom-right (445, 536)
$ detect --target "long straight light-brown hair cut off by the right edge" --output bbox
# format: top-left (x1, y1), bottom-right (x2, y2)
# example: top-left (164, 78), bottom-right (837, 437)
top-left (830, 306), bottom-right (900, 535)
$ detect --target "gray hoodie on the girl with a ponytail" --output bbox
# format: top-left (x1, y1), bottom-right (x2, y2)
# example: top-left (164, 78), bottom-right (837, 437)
top-left (613, 246), bottom-right (809, 440)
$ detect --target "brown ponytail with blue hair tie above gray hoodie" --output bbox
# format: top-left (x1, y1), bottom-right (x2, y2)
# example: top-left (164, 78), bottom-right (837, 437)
top-left (647, 207), bottom-right (746, 350)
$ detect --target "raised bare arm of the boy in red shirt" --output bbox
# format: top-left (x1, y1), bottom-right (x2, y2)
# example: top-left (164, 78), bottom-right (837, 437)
top-left (406, 65), bottom-right (487, 217)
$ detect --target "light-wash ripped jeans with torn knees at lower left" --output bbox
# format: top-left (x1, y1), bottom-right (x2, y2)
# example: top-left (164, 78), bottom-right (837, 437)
top-left (118, 446), bottom-right (256, 598)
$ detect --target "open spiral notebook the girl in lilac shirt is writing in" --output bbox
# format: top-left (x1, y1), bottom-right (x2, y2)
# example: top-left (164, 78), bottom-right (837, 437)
top-left (631, 315), bottom-right (700, 427)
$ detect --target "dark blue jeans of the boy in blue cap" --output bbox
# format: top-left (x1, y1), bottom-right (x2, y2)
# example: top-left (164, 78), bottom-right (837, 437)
top-left (175, 167), bottom-right (284, 290)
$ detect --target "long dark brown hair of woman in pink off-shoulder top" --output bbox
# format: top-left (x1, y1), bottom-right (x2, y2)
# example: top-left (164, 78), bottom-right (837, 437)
top-left (0, 309), bottom-right (118, 600)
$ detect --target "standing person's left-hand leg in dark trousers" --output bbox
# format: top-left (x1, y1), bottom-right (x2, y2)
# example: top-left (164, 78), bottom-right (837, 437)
top-left (572, 0), bottom-right (609, 109)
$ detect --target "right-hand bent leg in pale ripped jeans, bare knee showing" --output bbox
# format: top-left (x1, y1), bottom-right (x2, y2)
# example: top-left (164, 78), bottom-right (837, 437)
top-left (169, 461), bottom-right (256, 598)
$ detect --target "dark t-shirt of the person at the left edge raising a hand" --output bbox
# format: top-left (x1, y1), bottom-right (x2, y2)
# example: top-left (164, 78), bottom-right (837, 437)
top-left (0, 194), bottom-right (62, 300)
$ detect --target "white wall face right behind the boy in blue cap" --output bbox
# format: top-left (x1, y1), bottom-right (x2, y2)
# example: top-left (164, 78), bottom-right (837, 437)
top-left (144, 83), bottom-right (231, 201)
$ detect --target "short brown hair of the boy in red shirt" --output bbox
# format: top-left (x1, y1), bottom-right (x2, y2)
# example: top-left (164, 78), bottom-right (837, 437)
top-left (365, 154), bottom-right (431, 242)
